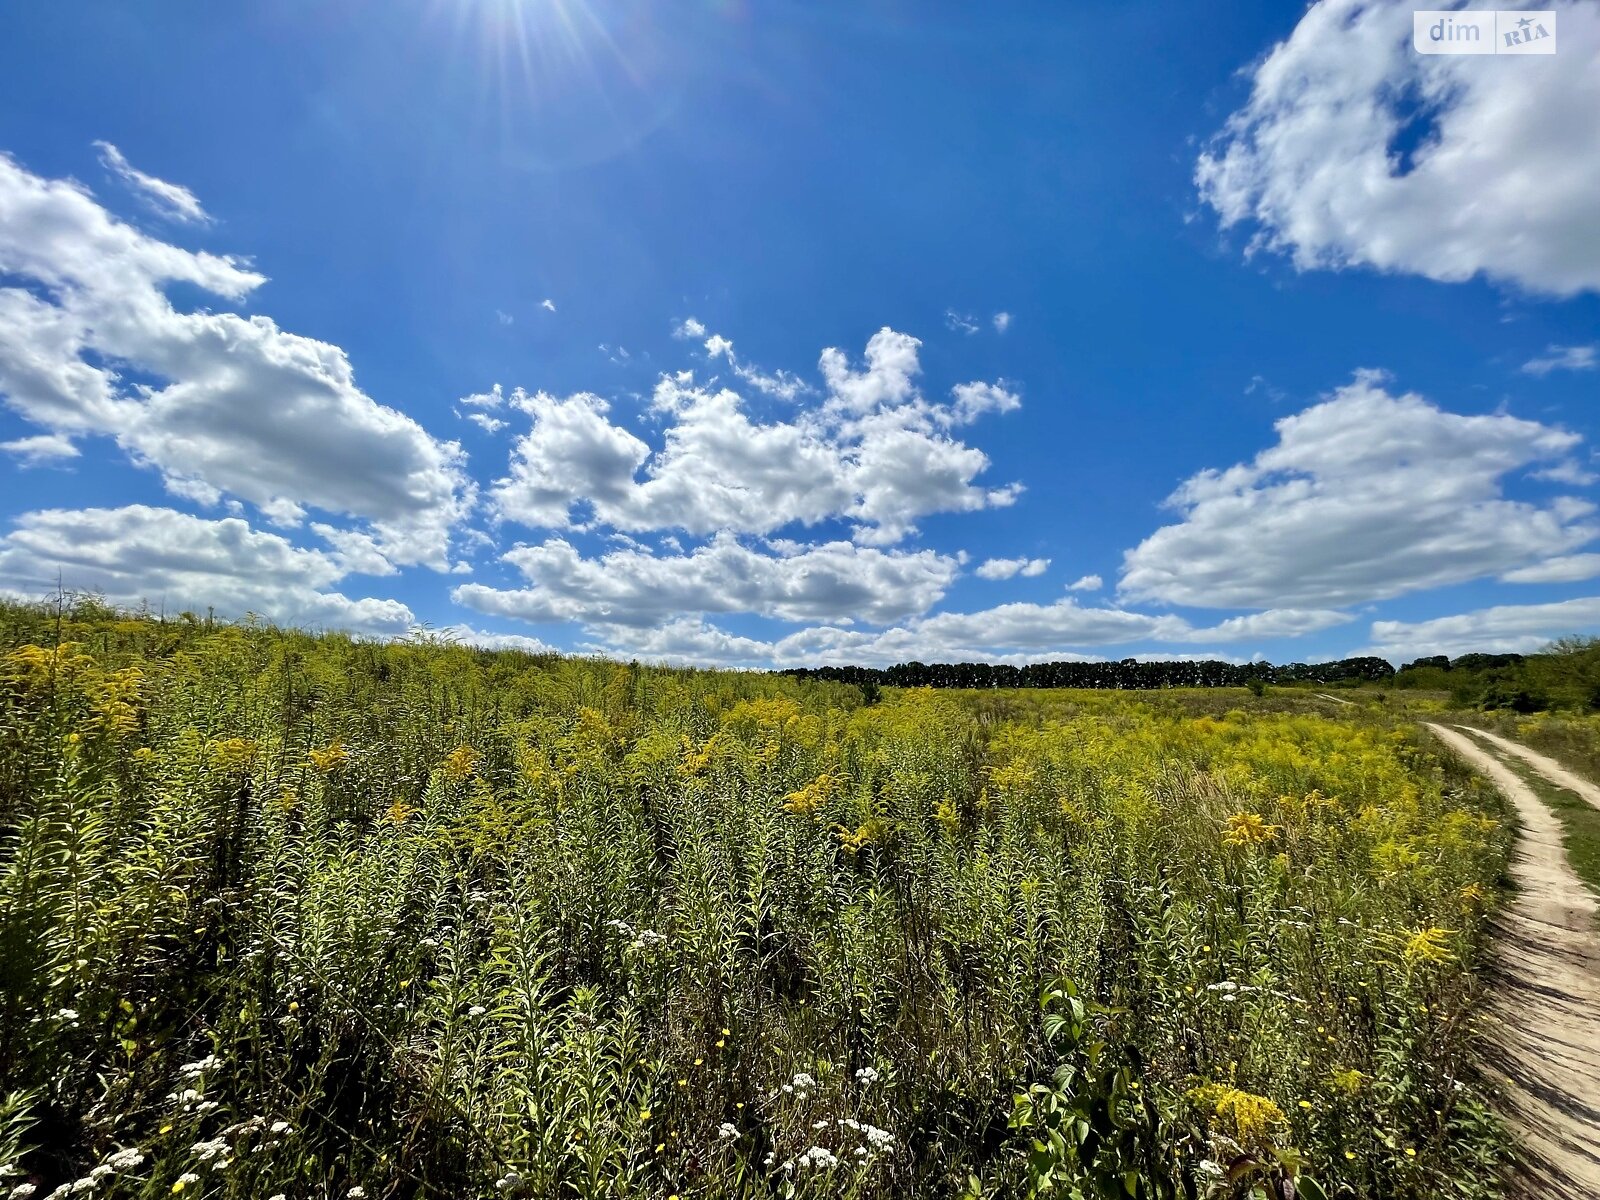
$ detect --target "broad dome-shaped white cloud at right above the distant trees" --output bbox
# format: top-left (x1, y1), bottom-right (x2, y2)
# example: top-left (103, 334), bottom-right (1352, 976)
top-left (1120, 373), bottom-right (1600, 608)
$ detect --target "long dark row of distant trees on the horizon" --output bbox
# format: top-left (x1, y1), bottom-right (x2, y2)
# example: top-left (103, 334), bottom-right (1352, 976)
top-left (782, 658), bottom-right (1395, 690)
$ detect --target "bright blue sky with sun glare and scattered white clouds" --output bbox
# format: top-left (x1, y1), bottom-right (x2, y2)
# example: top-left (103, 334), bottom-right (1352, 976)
top-left (0, 0), bottom-right (1600, 667)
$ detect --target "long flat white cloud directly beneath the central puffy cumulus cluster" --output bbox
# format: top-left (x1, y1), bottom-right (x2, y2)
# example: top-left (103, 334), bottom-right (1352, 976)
top-left (451, 534), bottom-right (958, 626)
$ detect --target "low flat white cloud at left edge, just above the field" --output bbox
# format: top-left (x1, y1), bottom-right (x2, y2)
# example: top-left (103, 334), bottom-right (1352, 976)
top-left (0, 504), bottom-right (416, 634)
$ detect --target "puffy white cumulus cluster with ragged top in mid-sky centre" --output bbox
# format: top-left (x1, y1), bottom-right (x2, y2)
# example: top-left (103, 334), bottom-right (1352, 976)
top-left (493, 330), bottom-right (1019, 546)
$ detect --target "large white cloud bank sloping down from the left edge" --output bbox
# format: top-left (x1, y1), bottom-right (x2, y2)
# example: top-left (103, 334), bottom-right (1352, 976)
top-left (0, 155), bottom-right (472, 566)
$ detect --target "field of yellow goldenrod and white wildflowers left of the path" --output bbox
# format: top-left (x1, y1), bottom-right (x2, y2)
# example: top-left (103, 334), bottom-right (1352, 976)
top-left (0, 605), bottom-right (1510, 1200)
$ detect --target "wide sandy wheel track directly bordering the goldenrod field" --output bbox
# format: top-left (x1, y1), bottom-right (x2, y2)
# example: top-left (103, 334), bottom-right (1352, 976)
top-left (1427, 723), bottom-right (1600, 1197)
